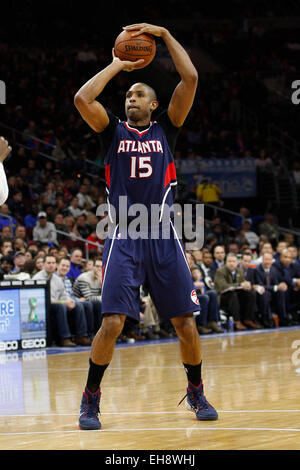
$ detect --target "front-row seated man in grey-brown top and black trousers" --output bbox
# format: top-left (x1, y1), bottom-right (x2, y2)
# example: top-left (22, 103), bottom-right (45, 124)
top-left (214, 253), bottom-right (260, 331)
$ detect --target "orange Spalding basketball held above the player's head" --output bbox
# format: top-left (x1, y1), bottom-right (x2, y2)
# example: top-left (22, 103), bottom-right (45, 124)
top-left (115, 30), bottom-right (156, 69)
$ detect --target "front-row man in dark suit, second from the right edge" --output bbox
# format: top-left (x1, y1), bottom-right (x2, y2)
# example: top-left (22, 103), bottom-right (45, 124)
top-left (254, 253), bottom-right (288, 328)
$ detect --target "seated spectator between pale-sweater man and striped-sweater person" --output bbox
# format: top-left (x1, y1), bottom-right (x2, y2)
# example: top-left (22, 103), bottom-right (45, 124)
top-left (56, 257), bottom-right (97, 340)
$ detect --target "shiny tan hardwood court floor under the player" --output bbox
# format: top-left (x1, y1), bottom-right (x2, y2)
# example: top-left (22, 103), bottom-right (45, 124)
top-left (0, 329), bottom-right (300, 450)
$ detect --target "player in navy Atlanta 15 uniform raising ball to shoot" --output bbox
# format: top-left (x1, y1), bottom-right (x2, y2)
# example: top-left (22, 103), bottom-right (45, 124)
top-left (74, 23), bottom-right (218, 429)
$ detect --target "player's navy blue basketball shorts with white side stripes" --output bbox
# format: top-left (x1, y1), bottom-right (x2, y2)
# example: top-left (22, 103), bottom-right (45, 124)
top-left (102, 221), bottom-right (200, 321)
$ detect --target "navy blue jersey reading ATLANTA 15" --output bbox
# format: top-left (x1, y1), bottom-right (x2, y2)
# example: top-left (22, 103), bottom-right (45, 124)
top-left (101, 111), bottom-right (179, 222)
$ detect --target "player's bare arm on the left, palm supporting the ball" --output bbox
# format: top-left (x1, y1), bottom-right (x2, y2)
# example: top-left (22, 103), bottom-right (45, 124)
top-left (74, 50), bottom-right (144, 132)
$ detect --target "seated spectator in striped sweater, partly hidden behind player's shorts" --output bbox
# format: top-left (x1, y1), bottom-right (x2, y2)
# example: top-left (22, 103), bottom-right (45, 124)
top-left (73, 258), bottom-right (102, 331)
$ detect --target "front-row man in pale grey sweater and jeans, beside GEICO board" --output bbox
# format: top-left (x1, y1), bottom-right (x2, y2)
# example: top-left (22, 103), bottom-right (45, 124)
top-left (32, 255), bottom-right (91, 347)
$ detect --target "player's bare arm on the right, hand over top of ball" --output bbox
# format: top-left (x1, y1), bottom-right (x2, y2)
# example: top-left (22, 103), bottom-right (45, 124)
top-left (124, 23), bottom-right (198, 127)
